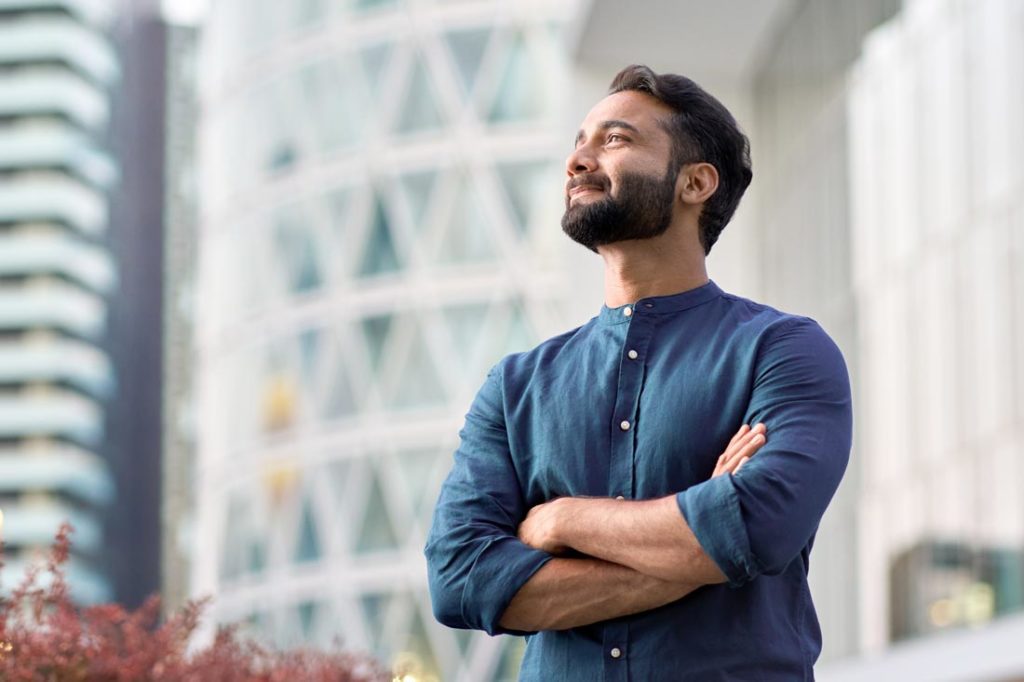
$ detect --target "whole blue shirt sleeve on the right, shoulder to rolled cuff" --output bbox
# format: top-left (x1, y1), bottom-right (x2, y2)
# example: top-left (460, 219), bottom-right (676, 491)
top-left (677, 317), bottom-right (853, 587)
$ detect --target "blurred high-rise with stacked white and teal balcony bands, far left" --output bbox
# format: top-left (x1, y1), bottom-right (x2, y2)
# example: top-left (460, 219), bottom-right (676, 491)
top-left (0, 0), bottom-right (120, 602)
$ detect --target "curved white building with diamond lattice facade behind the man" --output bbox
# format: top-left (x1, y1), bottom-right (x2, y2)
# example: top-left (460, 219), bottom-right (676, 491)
top-left (191, 0), bottom-right (577, 682)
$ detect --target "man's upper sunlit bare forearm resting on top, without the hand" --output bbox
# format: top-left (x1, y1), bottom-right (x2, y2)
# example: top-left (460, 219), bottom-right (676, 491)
top-left (558, 496), bottom-right (726, 585)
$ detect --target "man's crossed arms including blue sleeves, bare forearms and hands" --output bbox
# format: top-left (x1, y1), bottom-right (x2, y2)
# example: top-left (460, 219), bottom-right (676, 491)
top-left (424, 317), bottom-right (852, 634)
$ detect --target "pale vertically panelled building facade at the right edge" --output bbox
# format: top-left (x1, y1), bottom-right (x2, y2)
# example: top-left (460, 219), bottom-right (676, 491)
top-left (850, 0), bottom-right (1024, 655)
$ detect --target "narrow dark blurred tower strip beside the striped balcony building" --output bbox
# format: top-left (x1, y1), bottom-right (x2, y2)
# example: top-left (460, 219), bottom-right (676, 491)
top-left (100, 0), bottom-right (167, 607)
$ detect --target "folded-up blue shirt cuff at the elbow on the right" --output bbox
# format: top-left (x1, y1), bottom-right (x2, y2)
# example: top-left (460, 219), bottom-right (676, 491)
top-left (676, 474), bottom-right (761, 588)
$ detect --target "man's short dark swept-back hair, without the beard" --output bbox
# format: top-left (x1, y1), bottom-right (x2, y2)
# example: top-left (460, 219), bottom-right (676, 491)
top-left (608, 65), bottom-right (754, 255)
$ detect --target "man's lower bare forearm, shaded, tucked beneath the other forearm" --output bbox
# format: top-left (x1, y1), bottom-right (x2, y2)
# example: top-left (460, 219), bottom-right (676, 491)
top-left (501, 558), bottom-right (699, 632)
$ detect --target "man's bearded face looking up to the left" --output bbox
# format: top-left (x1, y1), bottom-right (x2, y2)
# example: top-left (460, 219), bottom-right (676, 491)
top-left (562, 91), bottom-right (678, 251)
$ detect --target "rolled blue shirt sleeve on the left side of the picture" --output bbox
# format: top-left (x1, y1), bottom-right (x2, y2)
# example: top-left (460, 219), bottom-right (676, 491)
top-left (425, 366), bottom-right (552, 635)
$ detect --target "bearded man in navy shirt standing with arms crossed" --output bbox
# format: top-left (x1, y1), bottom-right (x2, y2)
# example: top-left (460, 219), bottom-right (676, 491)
top-left (426, 66), bottom-right (852, 682)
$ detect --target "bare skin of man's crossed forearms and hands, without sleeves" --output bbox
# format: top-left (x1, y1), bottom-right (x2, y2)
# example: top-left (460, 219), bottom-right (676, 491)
top-left (501, 424), bottom-right (766, 631)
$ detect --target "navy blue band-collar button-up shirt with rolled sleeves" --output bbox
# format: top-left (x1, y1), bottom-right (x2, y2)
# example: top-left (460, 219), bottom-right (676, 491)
top-left (426, 281), bottom-right (852, 682)
